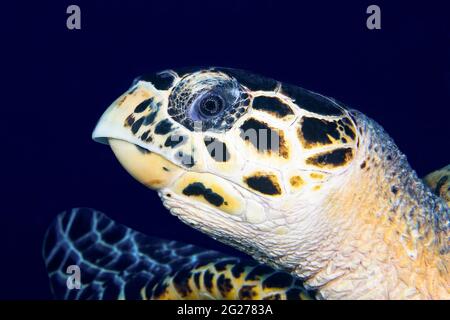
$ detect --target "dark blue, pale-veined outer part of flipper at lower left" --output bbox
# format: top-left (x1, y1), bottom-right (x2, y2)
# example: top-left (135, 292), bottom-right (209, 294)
top-left (43, 208), bottom-right (229, 299)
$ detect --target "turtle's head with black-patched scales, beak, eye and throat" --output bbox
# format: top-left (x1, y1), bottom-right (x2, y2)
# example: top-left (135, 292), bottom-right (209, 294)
top-left (93, 68), bottom-right (358, 268)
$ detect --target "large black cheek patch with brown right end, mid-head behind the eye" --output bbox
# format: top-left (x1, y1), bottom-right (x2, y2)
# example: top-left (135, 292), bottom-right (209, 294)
top-left (240, 118), bottom-right (289, 158)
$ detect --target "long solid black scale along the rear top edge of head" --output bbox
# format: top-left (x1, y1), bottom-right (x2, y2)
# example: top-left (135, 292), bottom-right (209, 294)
top-left (282, 84), bottom-right (343, 116)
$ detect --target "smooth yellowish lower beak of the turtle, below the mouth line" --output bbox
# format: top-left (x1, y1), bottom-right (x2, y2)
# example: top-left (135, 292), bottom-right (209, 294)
top-left (108, 139), bottom-right (185, 190)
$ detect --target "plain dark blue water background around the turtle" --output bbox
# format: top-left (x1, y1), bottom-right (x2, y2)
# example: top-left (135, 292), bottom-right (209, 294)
top-left (0, 0), bottom-right (450, 299)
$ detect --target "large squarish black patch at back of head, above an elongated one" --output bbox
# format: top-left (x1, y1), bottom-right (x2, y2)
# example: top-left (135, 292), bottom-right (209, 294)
top-left (298, 117), bottom-right (340, 148)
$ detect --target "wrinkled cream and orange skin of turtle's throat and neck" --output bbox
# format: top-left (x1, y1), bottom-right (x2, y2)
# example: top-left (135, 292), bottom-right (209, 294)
top-left (160, 111), bottom-right (450, 299)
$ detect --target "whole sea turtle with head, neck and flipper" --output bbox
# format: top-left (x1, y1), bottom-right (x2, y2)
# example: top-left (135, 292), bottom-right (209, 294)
top-left (44, 67), bottom-right (450, 299)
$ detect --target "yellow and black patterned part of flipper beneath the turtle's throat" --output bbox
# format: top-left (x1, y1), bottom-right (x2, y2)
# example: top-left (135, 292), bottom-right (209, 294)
top-left (152, 257), bottom-right (316, 300)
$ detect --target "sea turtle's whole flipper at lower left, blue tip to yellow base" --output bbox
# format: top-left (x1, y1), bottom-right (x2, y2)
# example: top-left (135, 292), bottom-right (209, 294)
top-left (43, 208), bottom-right (314, 300)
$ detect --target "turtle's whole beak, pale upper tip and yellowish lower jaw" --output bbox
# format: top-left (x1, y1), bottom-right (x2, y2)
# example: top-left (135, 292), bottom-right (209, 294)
top-left (92, 81), bottom-right (184, 189)
